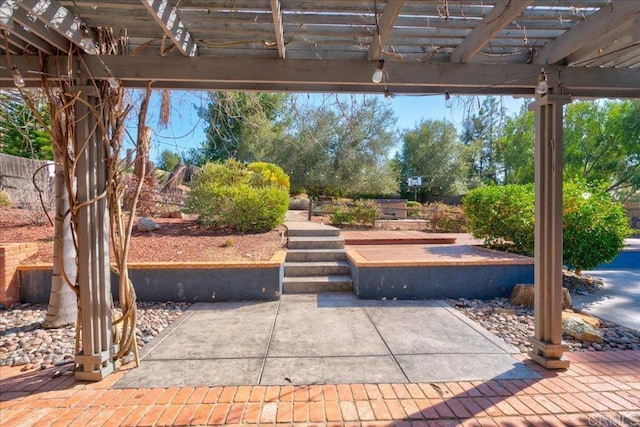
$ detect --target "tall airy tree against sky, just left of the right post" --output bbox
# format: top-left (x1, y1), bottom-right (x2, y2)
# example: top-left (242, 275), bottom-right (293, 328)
top-left (462, 96), bottom-right (505, 187)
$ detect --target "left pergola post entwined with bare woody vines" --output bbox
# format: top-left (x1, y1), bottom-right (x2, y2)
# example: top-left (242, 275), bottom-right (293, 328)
top-left (74, 87), bottom-right (114, 381)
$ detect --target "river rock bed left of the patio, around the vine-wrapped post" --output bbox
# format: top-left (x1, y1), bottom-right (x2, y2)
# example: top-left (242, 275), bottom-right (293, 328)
top-left (0, 302), bottom-right (189, 370)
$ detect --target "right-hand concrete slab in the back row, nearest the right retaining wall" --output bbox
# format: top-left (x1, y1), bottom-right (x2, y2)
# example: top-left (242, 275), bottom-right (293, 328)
top-left (366, 301), bottom-right (504, 355)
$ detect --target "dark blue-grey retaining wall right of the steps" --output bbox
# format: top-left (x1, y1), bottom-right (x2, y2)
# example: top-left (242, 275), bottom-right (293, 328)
top-left (350, 254), bottom-right (533, 300)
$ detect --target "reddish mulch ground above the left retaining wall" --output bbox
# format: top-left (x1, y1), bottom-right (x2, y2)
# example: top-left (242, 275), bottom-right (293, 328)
top-left (0, 208), bottom-right (283, 263)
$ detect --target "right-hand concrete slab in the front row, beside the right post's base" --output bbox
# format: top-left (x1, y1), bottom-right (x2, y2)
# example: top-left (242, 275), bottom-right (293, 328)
top-left (396, 353), bottom-right (542, 382)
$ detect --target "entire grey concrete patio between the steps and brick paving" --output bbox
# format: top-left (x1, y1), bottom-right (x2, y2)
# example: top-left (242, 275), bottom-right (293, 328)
top-left (116, 293), bottom-right (539, 388)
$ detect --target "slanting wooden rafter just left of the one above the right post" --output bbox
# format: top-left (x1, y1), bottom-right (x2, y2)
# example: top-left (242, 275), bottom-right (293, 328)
top-left (451, 0), bottom-right (532, 63)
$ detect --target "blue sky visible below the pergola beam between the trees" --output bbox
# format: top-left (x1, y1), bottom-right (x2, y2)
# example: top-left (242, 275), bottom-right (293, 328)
top-left (127, 91), bottom-right (524, 162)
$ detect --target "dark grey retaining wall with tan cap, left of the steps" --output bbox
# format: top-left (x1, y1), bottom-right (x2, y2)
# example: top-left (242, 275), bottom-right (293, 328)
top-left (19, 252), bottom-right (284, 304)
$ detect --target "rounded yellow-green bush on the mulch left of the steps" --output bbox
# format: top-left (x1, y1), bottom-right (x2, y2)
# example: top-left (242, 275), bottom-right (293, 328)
top-left (187, 160), bottom-right (289, 233)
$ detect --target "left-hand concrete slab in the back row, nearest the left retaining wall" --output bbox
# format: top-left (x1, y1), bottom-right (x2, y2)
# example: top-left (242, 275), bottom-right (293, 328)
top-left (148, 301), bottom-right (278, 360)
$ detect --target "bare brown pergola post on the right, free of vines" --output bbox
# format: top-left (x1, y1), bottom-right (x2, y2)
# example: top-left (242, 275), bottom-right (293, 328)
top-left (529, 94), bottom-right (571, 369)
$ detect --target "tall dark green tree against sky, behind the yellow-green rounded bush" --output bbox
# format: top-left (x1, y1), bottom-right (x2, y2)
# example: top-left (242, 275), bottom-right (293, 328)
top-left (188, 92), bottom-right (288, 164)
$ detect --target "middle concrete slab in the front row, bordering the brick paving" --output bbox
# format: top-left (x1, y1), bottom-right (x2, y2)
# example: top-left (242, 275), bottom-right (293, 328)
top-left (260, 356), bottom-right (407, 385)
